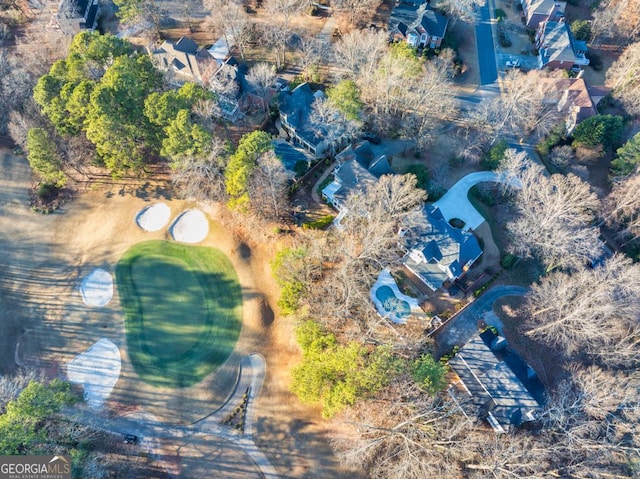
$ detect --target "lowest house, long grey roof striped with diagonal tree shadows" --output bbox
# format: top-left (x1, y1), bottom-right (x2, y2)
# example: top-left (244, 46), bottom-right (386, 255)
top-left (449, 328), bottom-right (544, 433)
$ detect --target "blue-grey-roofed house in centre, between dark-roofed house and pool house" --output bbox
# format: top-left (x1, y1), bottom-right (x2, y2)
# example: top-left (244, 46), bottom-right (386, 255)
top-left (322, 141), bottom-right (393, 212)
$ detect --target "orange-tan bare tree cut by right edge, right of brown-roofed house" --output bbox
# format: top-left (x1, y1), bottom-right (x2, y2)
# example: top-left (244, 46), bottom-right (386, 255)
top-left (607, 42), bottom-right (640, 115)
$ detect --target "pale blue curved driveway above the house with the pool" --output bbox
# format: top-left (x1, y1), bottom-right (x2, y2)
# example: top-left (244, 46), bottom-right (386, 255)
top-left (433, 171), bottom-right (500, 231)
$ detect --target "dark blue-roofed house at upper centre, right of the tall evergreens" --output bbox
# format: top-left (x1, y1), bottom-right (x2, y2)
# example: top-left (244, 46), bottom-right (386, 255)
top-left (278, 83), bottom-right (344, 159)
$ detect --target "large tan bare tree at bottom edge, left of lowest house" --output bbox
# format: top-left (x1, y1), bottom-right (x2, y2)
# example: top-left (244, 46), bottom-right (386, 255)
top-left (332, 378), bottom-right (473, 479)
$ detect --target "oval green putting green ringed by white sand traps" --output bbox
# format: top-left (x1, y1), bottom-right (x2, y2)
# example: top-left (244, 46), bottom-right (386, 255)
top-left (116, 241), bottom-right (242, 387)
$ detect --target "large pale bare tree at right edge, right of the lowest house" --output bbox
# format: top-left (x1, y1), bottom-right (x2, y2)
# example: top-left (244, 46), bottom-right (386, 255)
top-left (527, 256), bottom-right (640, 366)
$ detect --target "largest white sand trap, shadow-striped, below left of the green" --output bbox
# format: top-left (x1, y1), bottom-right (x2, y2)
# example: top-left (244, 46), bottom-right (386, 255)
top-left (67, 338), bottom-right (121, 409)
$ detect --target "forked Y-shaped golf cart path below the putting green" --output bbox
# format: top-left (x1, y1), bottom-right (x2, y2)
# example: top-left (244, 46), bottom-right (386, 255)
top-left (70, 354), bottom-right (279, 479)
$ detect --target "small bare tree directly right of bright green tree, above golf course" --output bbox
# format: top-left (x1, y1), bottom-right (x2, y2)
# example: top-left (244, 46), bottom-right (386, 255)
top-left (249, 151), bottom-right (293, 220)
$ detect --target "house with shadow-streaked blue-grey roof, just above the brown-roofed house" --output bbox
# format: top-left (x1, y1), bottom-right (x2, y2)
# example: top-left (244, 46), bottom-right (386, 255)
top-left (536, 21), bottom-right (589, 70)
